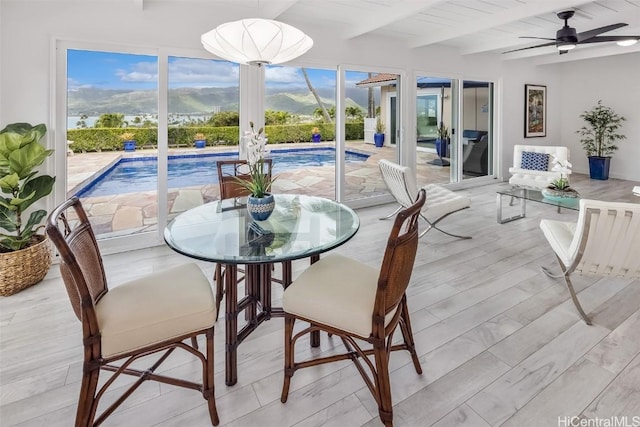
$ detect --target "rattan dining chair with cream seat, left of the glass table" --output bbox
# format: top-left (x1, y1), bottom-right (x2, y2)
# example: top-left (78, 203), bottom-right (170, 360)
top-left (46, 197), bottom-right (219, 426)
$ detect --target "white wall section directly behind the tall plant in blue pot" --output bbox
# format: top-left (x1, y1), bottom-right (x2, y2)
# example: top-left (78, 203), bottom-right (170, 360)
top-left (557, 52), bottom-right (640, 181)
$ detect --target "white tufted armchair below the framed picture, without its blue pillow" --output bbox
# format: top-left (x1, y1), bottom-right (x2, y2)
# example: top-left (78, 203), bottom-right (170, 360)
top-left (509, 145), bottom-right (571, 189)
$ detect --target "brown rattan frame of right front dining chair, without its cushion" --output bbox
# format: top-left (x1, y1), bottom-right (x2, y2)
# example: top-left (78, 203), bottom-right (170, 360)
top-left (280, 189), bottom-right (426, 426)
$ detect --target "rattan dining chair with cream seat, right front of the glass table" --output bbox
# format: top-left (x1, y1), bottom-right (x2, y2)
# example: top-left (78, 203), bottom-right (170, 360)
top-left (280, 190), bottom-right (426, 426)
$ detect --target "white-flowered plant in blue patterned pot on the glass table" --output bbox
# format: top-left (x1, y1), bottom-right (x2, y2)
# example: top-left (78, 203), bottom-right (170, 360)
top-left (237, 122), bottom-right (276, 221)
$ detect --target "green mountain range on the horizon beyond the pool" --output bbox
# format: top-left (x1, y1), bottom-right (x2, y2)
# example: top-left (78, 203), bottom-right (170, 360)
top-left (67, 87), bottom-right (379, 116)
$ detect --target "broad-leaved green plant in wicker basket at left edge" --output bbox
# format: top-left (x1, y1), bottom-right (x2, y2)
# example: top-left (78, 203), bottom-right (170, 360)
top-left (0, 123), bottom-right (55, 296)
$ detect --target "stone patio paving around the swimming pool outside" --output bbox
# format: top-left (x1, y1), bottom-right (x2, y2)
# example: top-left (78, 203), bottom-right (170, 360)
top-left (67, 141), bottom-right (449, 237)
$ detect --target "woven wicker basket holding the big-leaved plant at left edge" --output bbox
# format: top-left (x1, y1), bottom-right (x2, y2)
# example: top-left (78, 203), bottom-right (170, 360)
top-left (0, 235), bottom-right (51, 297)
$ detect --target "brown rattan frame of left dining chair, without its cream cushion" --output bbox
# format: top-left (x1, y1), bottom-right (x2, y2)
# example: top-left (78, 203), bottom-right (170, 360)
top-left (46, 197), bottom-right (219, 427)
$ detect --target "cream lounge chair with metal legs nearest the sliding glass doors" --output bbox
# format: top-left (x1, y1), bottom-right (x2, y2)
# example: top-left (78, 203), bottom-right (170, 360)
top-left (378, 159), bottom-right (471, 239)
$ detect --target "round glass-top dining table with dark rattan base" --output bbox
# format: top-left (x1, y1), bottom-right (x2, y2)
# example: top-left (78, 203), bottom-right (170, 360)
top-left (164, 194), bottom-right (360, 385)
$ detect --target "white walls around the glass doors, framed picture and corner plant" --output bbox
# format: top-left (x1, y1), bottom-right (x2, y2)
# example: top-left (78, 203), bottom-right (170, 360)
top-left (0, 0), bottom-right (640, 189)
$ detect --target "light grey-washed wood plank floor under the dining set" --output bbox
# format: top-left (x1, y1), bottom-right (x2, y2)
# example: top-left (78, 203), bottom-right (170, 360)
top-left (0, 175), bottom-right (640, 427)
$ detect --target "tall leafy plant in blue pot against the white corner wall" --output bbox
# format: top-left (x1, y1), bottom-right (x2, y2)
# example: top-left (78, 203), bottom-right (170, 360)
top-left (576, 100), bottom-right (626, 180)
